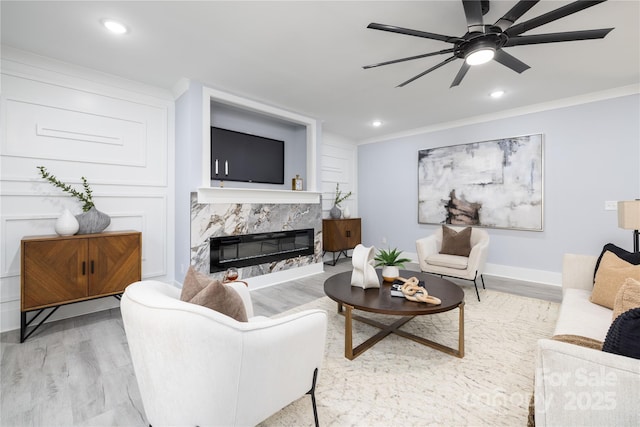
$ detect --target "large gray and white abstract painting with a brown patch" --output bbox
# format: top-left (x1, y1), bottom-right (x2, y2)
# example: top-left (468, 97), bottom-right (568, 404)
top-left (418, 134), bottom-right (543, 231)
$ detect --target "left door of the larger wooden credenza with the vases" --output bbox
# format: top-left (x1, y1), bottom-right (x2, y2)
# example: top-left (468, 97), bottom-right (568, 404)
top-left (22, 239), bottom-right (89, 311)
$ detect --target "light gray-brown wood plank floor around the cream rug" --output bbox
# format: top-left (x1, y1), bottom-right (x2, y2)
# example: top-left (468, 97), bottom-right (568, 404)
top-left (0, 259), bottom-right (561, 427)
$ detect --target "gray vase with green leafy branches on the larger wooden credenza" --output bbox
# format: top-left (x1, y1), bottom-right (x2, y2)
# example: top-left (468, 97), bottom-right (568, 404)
top-left (37, 166), bottom-right (111, 234)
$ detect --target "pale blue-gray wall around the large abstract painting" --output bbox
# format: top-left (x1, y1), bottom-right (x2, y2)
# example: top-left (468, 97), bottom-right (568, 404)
top-left (358, 95), bottom-right (640, 278)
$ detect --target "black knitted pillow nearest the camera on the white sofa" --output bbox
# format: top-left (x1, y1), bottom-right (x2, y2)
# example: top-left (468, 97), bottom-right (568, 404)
top-left (602, 307), bottom-right (640, 359)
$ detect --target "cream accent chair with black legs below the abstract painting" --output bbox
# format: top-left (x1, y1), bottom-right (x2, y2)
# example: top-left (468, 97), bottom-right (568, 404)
top-left (416, 225), bottom-right (489, 301)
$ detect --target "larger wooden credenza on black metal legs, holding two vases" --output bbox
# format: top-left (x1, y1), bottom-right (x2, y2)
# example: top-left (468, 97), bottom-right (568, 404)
top-left (20, 231), bottom-right (142, 342)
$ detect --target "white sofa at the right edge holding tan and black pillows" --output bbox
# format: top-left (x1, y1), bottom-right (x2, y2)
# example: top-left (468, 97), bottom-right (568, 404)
top-left (535, 254), bottom-right (640, 426)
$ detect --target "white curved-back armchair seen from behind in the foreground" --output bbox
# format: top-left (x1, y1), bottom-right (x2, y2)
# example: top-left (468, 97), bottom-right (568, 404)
top-left (121, 281), bottom-right (327, 426)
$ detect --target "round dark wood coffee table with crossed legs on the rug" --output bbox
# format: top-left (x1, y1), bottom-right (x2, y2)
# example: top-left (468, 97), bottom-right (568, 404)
top-left (324, 270), bottom-right (464, 360)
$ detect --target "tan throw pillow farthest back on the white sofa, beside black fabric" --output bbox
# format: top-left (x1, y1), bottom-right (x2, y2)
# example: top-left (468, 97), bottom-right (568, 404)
top-left (589, 251), bottom-right (640, 310)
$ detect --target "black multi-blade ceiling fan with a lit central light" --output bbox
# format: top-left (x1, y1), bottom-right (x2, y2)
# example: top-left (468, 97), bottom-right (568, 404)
top-left (363, 0), bottom-right (613, 87)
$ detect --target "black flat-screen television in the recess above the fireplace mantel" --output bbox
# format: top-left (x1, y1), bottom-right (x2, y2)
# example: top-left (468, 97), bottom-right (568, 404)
top-left (211, 126), bottom-right (284, 184)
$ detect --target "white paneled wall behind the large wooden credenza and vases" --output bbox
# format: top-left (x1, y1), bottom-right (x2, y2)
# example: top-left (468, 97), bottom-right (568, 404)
top-left (0, 48), bottom-right (175, 331)
